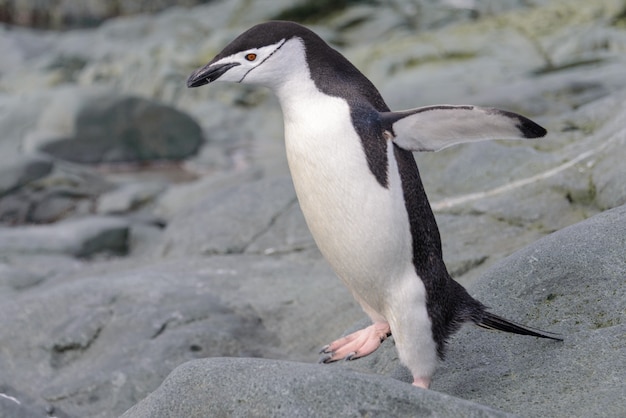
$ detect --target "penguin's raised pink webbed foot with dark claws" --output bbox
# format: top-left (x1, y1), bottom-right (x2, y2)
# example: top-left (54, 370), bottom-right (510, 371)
top-left (320, 322), bottom-right (391, 363)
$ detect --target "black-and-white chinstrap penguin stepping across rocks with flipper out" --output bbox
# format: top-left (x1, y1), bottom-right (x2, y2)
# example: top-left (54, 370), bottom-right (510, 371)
top-left (187, 21), bottom-right (560, 388)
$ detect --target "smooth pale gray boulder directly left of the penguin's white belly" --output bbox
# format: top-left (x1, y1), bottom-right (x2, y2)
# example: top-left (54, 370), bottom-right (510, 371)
top-left (156, 177), bottom-right (313, 256)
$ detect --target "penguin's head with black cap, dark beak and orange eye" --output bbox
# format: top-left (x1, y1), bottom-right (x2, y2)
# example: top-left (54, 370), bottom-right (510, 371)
top-left (187, 21), bottom-right (317, 88)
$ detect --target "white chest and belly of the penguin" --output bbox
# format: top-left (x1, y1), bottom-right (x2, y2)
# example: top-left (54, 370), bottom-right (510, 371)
top-left (283, 92), bottom-right (413, 309)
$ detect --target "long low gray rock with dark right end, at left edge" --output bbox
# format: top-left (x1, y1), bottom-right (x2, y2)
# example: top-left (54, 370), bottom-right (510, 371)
top-left (0, 216), bottom-right (129, 257)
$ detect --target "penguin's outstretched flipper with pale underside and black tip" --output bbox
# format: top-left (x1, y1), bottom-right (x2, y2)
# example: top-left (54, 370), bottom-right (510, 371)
top-left (380, 105), bottom-right (547, 151)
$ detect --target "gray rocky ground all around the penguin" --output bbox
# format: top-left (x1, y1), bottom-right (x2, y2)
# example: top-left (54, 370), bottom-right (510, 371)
top-left (0, 0), bottom-right (626, 417)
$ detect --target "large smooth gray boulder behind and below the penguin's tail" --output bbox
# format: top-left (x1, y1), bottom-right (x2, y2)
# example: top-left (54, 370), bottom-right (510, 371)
top-left (433, 206), bottom-right (626, 417)
